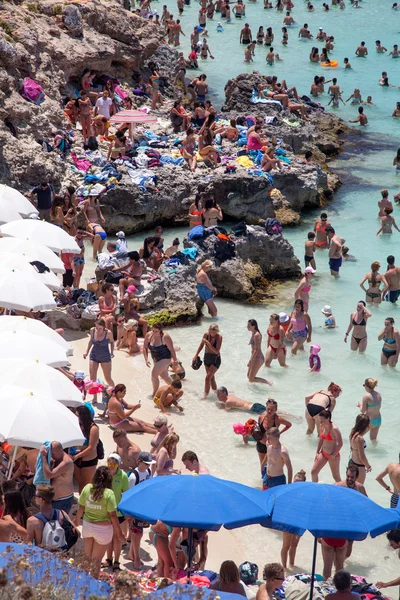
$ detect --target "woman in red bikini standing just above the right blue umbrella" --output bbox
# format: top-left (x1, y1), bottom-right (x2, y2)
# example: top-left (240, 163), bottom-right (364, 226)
top-left (311, 410), bottom-right (343, 482)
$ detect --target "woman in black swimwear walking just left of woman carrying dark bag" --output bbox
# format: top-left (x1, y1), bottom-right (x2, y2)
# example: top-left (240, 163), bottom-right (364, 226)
top-left (143, 323), bottom-right (176, 396)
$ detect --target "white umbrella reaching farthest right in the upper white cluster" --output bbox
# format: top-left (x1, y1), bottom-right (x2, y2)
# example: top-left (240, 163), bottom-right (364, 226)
top-left (0, 219), bottom-right (81, 254)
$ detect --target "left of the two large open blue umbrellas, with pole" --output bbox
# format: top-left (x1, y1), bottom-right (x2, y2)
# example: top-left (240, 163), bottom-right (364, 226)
top-left (118, 475), bottom-right (267, 576)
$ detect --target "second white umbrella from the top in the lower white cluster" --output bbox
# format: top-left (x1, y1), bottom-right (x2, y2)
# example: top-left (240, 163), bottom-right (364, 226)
top-left (0, 328), bottom-right (68, 366)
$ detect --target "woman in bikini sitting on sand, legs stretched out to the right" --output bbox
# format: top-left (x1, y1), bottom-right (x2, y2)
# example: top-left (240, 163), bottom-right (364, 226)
top-left (108, 383), bottom-right (157, 435)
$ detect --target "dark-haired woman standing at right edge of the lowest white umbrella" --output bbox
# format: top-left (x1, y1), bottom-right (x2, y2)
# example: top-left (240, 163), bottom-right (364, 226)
top-left (71, 406), bottom-right (100, 492)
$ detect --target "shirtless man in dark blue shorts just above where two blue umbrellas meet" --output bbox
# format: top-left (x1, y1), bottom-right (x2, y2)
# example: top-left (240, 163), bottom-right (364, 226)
top-left (261, 427), bottom-right (293, 490)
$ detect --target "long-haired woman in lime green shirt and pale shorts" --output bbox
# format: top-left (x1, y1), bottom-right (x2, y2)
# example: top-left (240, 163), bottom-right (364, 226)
top-left (74, 467), bottom-right (125, 577)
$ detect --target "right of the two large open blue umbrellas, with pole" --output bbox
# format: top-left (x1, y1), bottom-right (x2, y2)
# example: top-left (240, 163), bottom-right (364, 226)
top-left (262, 482), bottom-right (400, 599)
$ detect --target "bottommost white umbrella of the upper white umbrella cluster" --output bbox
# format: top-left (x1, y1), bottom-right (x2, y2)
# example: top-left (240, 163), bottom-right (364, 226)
top-left (0, 269), bottom-right (56, 312)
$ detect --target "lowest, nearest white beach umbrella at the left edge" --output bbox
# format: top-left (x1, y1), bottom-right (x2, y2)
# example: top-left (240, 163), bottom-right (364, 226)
top-left (0, 385), bottom-right (85, 448)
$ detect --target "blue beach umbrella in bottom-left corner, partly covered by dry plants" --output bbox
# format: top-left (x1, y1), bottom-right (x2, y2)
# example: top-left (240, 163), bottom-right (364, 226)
top-left (0, 542), bottom-right (111, 600)
